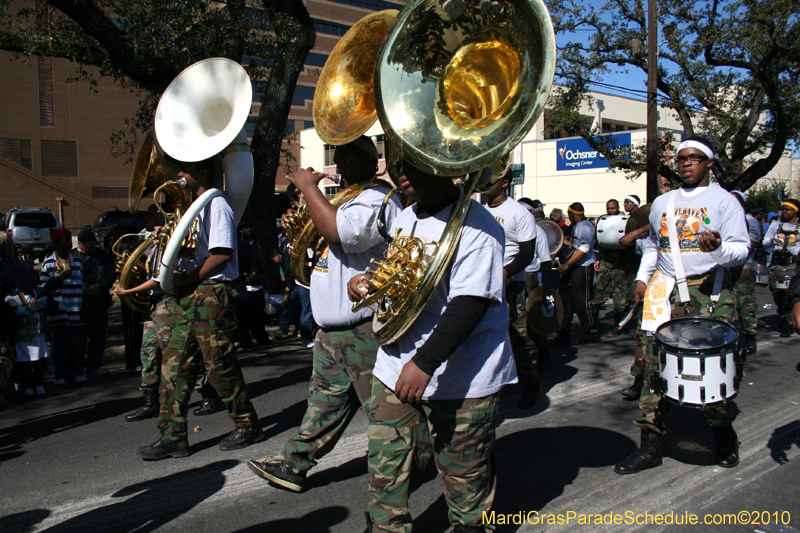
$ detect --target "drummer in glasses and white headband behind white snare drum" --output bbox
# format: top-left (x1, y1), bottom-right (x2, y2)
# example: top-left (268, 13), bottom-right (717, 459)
top-left (614, 138), bottom-right (749, 474)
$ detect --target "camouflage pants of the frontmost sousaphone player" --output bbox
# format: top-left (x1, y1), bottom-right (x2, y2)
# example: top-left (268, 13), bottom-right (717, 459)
top-left (368, 379), bottom-right (500, 533)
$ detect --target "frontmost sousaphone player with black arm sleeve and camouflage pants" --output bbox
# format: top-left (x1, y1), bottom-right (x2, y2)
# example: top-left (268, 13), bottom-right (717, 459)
top-left (348, 158), bottom-right (516, 533)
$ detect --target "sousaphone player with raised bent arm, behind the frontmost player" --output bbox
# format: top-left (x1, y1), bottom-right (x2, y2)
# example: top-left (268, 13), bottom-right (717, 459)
top-left (248, 136), bottom-right (431, 492)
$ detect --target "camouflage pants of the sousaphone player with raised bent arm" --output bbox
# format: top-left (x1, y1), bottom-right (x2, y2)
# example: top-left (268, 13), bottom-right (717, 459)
top-left (283, 322), bottom-right (380, 473)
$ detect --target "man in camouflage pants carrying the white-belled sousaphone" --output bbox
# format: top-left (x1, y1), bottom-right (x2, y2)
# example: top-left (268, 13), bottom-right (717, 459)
top-left (137, 159), bottom-right (263, 460)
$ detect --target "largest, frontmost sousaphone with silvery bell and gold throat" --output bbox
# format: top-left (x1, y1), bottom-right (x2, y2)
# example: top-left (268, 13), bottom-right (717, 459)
top-left (354, 0), bottom-right (556, 344)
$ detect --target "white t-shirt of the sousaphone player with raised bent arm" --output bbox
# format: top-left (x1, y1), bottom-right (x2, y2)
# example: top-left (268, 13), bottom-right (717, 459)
top-left (311, 187), bottom-right (403, 328)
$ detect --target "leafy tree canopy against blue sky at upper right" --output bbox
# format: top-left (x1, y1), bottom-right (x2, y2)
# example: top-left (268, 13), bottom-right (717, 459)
top-left (548, 0), bottom-right (800, 190)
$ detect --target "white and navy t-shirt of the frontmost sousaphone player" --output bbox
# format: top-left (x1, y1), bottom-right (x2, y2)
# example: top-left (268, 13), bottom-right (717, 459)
top-left (374, 200), bottom-right (517, 400)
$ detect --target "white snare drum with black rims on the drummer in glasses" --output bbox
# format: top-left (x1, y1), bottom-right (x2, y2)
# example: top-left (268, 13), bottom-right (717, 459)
top-left (654, 317), bottom-right (740, 408)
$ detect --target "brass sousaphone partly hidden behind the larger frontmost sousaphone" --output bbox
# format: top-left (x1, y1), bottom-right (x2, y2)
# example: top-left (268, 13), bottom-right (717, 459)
top-left (284, 9), bottom-right (398, 287)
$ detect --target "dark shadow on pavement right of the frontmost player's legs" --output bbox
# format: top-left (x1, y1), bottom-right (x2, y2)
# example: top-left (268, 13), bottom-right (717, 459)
top-left (414, 426), bottom-right (637, 532)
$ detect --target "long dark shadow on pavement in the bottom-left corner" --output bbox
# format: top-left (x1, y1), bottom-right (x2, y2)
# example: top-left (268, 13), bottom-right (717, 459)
top-left (0, 460), bottom-right (239, 533)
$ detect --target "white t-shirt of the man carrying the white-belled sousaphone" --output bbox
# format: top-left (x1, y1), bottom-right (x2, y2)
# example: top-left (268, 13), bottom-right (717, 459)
top-left (178, 196), bottom-right (239, 281)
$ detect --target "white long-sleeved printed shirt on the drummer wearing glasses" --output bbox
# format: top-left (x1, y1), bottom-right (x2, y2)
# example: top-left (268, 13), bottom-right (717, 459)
top-left (636, 185), bottom-right (750, 283)
